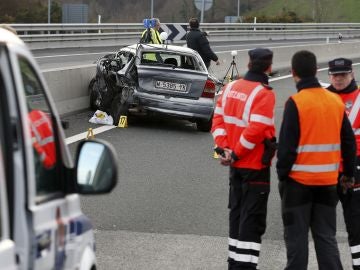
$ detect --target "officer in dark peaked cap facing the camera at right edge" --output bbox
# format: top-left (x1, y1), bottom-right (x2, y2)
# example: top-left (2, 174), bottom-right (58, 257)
top-left (328, 58), bottom-right (360, 270)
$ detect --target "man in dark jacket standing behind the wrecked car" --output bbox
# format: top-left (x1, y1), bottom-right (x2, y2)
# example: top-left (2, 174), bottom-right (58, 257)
top-left (186, 18), bottom-right (220, 68)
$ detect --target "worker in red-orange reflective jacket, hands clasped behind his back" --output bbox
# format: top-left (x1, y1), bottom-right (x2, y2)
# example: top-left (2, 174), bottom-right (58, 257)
top-left (211, 48), bottom-right (275, 269)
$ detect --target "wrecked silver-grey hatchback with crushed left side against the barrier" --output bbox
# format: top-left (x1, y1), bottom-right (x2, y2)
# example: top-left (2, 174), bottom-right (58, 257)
top-left (89, 44), bottom-right (220, 132)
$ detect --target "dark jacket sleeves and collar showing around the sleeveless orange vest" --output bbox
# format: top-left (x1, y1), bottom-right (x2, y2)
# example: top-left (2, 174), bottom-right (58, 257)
top-left (276, 78), bottom-right (356, 181)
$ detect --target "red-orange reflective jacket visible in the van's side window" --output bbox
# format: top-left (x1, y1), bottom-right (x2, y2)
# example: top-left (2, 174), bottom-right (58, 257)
top-left (28, 110), bottom-right (56, 169)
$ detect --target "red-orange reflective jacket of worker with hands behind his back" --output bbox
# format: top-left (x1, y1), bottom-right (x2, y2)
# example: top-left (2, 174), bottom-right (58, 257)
top-left (211, 79), bottom-right (275, 169)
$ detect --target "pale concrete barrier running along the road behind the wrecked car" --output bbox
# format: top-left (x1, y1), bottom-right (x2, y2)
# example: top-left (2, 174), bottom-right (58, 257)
top-left (43, 40), bottom-right (360, 115)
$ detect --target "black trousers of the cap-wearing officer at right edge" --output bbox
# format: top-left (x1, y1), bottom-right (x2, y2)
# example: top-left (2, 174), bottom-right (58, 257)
top-left (338, 157), bottom-right (360, 270)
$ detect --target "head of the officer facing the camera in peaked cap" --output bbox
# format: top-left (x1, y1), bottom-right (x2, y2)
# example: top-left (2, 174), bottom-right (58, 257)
top-left (329, 58), bottom-right (354, 91)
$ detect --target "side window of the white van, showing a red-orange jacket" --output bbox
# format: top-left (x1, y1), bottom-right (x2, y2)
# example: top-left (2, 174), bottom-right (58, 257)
top-left (19, 58), bottom-right (61, 197)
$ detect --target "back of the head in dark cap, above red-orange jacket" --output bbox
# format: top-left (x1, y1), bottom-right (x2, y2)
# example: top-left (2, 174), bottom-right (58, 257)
top-left (248, 48), bottom-right (273, 73)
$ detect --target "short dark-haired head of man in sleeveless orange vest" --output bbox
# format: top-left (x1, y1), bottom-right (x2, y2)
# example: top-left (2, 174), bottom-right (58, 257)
top-left (291, 50), bottom-right (317, 78)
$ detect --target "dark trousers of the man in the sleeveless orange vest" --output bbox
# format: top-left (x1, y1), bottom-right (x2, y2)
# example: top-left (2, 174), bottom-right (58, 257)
top-left (279, 179), bottom-right (343, 270)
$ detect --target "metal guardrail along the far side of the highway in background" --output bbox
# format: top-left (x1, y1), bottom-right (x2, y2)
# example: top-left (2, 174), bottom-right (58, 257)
top-left (11, 23), bottom-right (360, 49)
